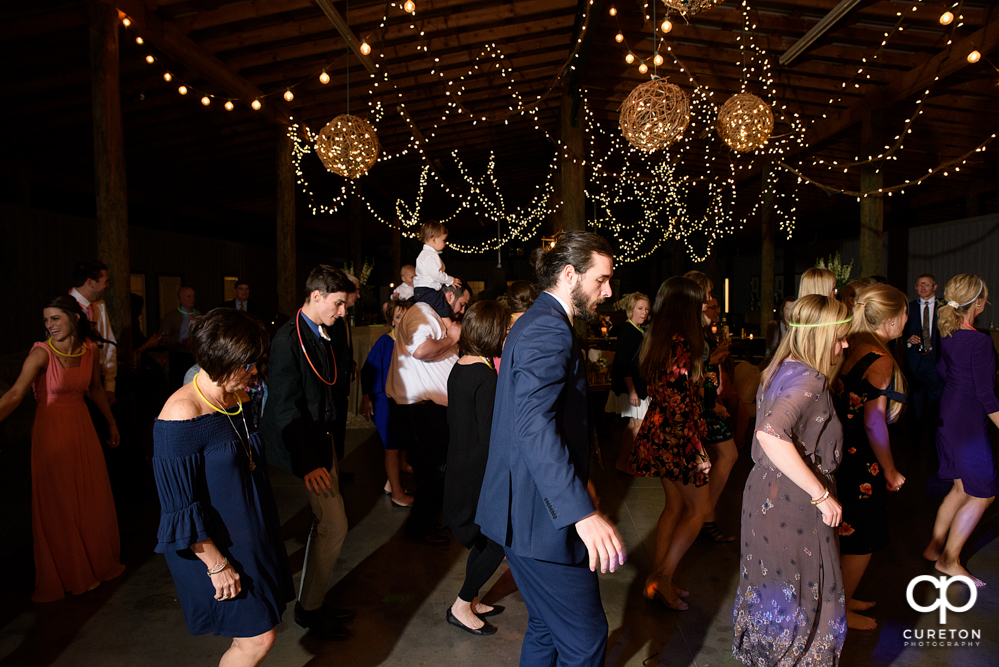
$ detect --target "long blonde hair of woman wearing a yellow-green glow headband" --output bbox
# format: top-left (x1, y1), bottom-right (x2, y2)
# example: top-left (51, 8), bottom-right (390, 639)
top-left (760, 294), bottom-right (850, 389)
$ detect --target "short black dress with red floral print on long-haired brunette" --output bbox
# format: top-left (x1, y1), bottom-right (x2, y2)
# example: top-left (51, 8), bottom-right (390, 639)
top-left (631, 334), bottom-right (708, 486)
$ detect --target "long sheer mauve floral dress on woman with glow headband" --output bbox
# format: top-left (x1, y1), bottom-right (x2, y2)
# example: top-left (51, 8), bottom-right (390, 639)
top-left (732, 360), bottom-right (846, 667)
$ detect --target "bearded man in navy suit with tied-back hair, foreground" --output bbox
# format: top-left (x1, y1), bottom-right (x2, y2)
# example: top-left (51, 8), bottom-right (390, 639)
top-left (475, 232), bottom-right (626, 667)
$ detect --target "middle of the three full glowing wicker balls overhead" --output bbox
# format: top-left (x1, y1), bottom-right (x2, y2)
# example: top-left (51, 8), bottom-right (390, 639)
top-left (619, 79), bottom-right (690, 152)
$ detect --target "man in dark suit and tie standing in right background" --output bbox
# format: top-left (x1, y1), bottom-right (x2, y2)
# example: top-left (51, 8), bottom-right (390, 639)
top-left (905, 273), bottom-right (943, 427)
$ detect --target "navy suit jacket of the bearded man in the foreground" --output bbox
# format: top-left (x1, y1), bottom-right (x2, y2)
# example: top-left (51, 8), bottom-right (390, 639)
top-left (475, 292), bottom-right (594, 565)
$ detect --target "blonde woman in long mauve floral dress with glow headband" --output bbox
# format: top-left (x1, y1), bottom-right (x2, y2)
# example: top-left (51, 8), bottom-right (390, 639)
top-left (732, 294), bottom-right (850, 667)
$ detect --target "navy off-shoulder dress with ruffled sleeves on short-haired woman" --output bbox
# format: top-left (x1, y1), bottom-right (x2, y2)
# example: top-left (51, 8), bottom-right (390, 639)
top-left (153, 412), bottom-right (295, 637)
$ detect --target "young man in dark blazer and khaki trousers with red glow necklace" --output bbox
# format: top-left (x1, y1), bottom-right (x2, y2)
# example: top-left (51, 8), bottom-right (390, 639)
top-left (260, 264), bottom-right (354, 639)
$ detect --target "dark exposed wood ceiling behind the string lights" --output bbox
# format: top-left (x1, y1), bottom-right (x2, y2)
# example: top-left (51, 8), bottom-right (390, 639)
top-left (0, 0), bottom-right (999, 256)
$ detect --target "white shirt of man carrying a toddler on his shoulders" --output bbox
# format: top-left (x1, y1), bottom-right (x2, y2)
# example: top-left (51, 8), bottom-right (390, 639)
top-left (385, 302), bottom-right (458, 407)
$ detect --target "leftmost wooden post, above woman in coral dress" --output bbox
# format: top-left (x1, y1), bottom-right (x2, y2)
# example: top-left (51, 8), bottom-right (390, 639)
top-left (90, 0), bottom-right (132, 368)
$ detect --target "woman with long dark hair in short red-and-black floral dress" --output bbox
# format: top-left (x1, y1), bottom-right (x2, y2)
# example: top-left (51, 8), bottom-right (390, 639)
top-left (631, 276), bottom-right (711, 611)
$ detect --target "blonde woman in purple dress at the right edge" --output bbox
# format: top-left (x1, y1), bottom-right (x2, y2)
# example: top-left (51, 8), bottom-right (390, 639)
top-left (923, 273), bottom-right (999, 586)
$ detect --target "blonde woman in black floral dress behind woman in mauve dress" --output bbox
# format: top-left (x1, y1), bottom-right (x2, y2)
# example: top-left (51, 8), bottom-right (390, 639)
top-left (835, 284), bottom-right (908, 630)
